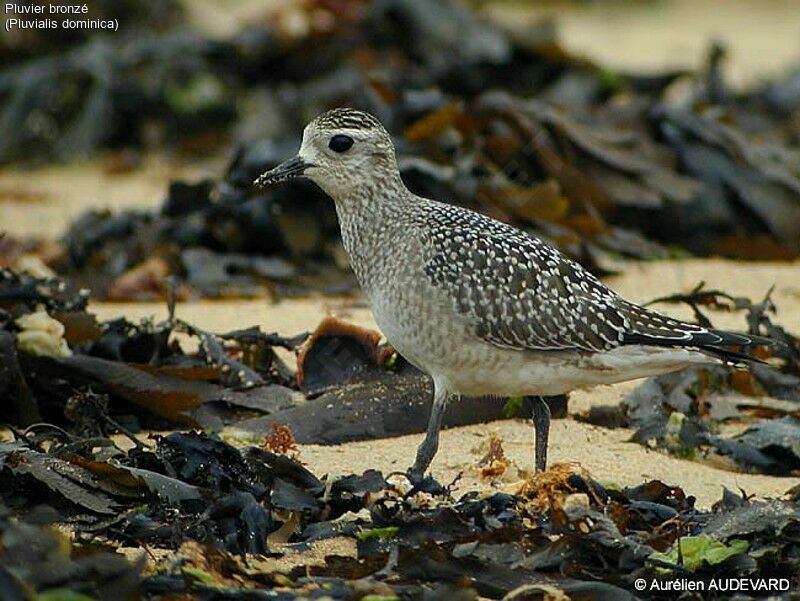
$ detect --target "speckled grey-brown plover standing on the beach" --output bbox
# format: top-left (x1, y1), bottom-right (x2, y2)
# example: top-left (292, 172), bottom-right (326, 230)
top-left (255, 108), bottom-right (768, 478)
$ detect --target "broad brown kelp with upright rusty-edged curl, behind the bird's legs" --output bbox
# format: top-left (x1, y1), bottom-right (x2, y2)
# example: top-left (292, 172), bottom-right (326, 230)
top-left (236, 317), bottom-right (513, 445)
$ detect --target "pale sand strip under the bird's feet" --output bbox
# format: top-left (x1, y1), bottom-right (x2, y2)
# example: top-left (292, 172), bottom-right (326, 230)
top-left (300, 418), bottom-right (800, 508)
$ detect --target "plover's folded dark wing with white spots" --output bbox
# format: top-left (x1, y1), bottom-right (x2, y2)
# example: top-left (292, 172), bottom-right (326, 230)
top-left (418, 204), bottom-right (724, 351)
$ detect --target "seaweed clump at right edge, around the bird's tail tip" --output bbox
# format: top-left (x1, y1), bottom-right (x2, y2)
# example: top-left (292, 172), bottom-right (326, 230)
top-left (583, 282), bottom-right (800, 475)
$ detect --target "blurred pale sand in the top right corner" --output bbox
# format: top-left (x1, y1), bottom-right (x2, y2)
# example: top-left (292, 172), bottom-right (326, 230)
top-left (486, 0), bottom-right (800, 86)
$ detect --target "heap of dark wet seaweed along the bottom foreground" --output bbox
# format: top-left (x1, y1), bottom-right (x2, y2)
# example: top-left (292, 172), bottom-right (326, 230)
top-left (0, 428), bottom-right (800, 601)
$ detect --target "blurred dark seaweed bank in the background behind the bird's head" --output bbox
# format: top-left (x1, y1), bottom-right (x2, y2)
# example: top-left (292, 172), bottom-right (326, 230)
top-left (0, 0), bottom-right (800, 299)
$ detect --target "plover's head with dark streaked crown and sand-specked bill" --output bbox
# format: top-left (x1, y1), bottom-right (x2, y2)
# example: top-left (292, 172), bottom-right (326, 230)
top-left (254, 108), bottom-right (399, 200)
